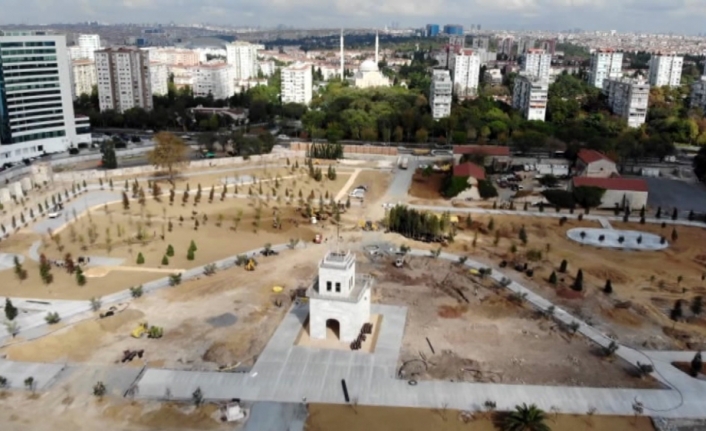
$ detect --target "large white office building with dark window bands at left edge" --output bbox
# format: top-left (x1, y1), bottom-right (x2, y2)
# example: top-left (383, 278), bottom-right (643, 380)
top-left (0, 30), bottom-right (91, 166)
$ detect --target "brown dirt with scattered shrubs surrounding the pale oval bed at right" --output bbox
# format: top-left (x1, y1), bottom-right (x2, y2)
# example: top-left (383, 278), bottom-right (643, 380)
top-left (440, 216), bottom-right (706, 350)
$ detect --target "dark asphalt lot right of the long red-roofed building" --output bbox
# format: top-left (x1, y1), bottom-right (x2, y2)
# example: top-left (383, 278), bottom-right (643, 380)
top-left (645, 178), bottom-right (706, 214)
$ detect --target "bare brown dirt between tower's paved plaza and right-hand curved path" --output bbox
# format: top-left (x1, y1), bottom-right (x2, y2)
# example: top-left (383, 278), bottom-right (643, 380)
top-left (364, 257), bottom-right (655, 387)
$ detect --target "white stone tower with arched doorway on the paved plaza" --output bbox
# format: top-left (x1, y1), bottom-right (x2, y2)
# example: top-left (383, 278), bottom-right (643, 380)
top-left (307, 251), bottom-right (373, 343)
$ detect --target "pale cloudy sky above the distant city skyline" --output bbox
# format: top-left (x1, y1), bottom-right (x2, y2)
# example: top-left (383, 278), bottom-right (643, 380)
top-left (0, 0), bottom-right (706, 34)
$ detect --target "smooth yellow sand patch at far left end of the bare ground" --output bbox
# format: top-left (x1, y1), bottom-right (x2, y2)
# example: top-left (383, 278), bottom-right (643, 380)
top-left (4, 309), bottom-right (144, 362)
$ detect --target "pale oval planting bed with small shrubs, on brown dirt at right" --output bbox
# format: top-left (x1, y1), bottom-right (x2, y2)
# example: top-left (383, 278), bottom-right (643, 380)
top-left (566, 228), bottom-right (669, 251)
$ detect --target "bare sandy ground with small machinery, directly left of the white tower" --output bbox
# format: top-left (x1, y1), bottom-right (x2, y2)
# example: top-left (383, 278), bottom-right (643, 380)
top-left (0, 250), bottom-right (325, 370)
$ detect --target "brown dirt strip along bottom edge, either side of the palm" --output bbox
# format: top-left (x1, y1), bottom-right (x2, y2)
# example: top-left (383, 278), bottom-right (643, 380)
top-left (304, 404), bottom-right (654, 431)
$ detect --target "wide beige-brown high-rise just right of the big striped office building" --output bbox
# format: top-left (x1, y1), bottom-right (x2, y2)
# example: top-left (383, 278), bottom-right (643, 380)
top-left (96, 48), bottom-right (153, 112)
